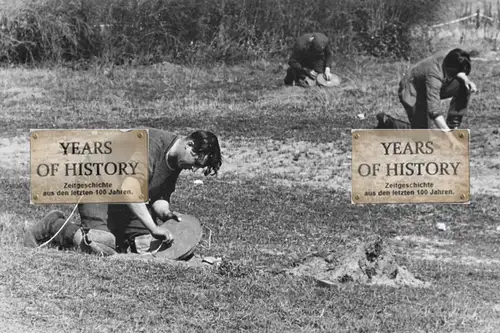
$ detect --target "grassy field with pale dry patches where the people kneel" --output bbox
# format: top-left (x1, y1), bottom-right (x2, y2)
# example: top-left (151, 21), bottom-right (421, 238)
top-left (0, 44), bottom-right (500, 333)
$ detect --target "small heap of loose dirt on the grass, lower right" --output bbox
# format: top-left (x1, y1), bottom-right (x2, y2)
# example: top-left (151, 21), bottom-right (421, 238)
top-left (288, 236), bottom-right (430, 287)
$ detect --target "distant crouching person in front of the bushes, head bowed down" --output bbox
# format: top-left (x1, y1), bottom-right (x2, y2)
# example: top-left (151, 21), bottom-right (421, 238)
top-left (285, 32), bottom-right (339, 87)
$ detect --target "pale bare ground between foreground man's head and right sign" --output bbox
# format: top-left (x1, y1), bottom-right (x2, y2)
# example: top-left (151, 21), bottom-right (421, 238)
top-left (220, 139), bottom-right (351, 191)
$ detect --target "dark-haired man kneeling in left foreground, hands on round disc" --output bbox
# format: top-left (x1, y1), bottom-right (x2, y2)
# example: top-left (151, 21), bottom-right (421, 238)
top-left (24, 129), bottom-right (222, 255)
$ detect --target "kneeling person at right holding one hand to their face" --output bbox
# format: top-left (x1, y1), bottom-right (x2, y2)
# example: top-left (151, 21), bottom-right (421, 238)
top-left (377, 48), bottom-right (476, 131)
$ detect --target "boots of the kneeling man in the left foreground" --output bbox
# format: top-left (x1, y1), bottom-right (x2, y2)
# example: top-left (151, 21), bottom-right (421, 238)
top-left (24, 210), bottom-right (79, 248)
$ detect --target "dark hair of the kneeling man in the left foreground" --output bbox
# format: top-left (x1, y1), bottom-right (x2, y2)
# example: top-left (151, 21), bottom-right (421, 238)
top-left (188, 130), bottom-right (222, 176)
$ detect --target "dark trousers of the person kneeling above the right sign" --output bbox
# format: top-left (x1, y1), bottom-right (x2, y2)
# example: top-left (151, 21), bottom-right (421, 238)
top-left (398, 79), bottom-right (470, 129)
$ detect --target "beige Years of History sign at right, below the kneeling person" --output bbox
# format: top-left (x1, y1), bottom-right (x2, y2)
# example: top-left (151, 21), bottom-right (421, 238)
top-left (351, 129), bottom-right (470, 204)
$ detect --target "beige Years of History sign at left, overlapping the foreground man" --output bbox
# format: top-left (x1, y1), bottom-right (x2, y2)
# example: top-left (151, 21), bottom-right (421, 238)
top-left (30, 129), bottom-right (149, 204)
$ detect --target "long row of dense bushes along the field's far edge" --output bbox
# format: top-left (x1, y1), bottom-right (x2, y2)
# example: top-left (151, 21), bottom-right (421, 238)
top-left (0, 0), bottom-right (452, 63)
